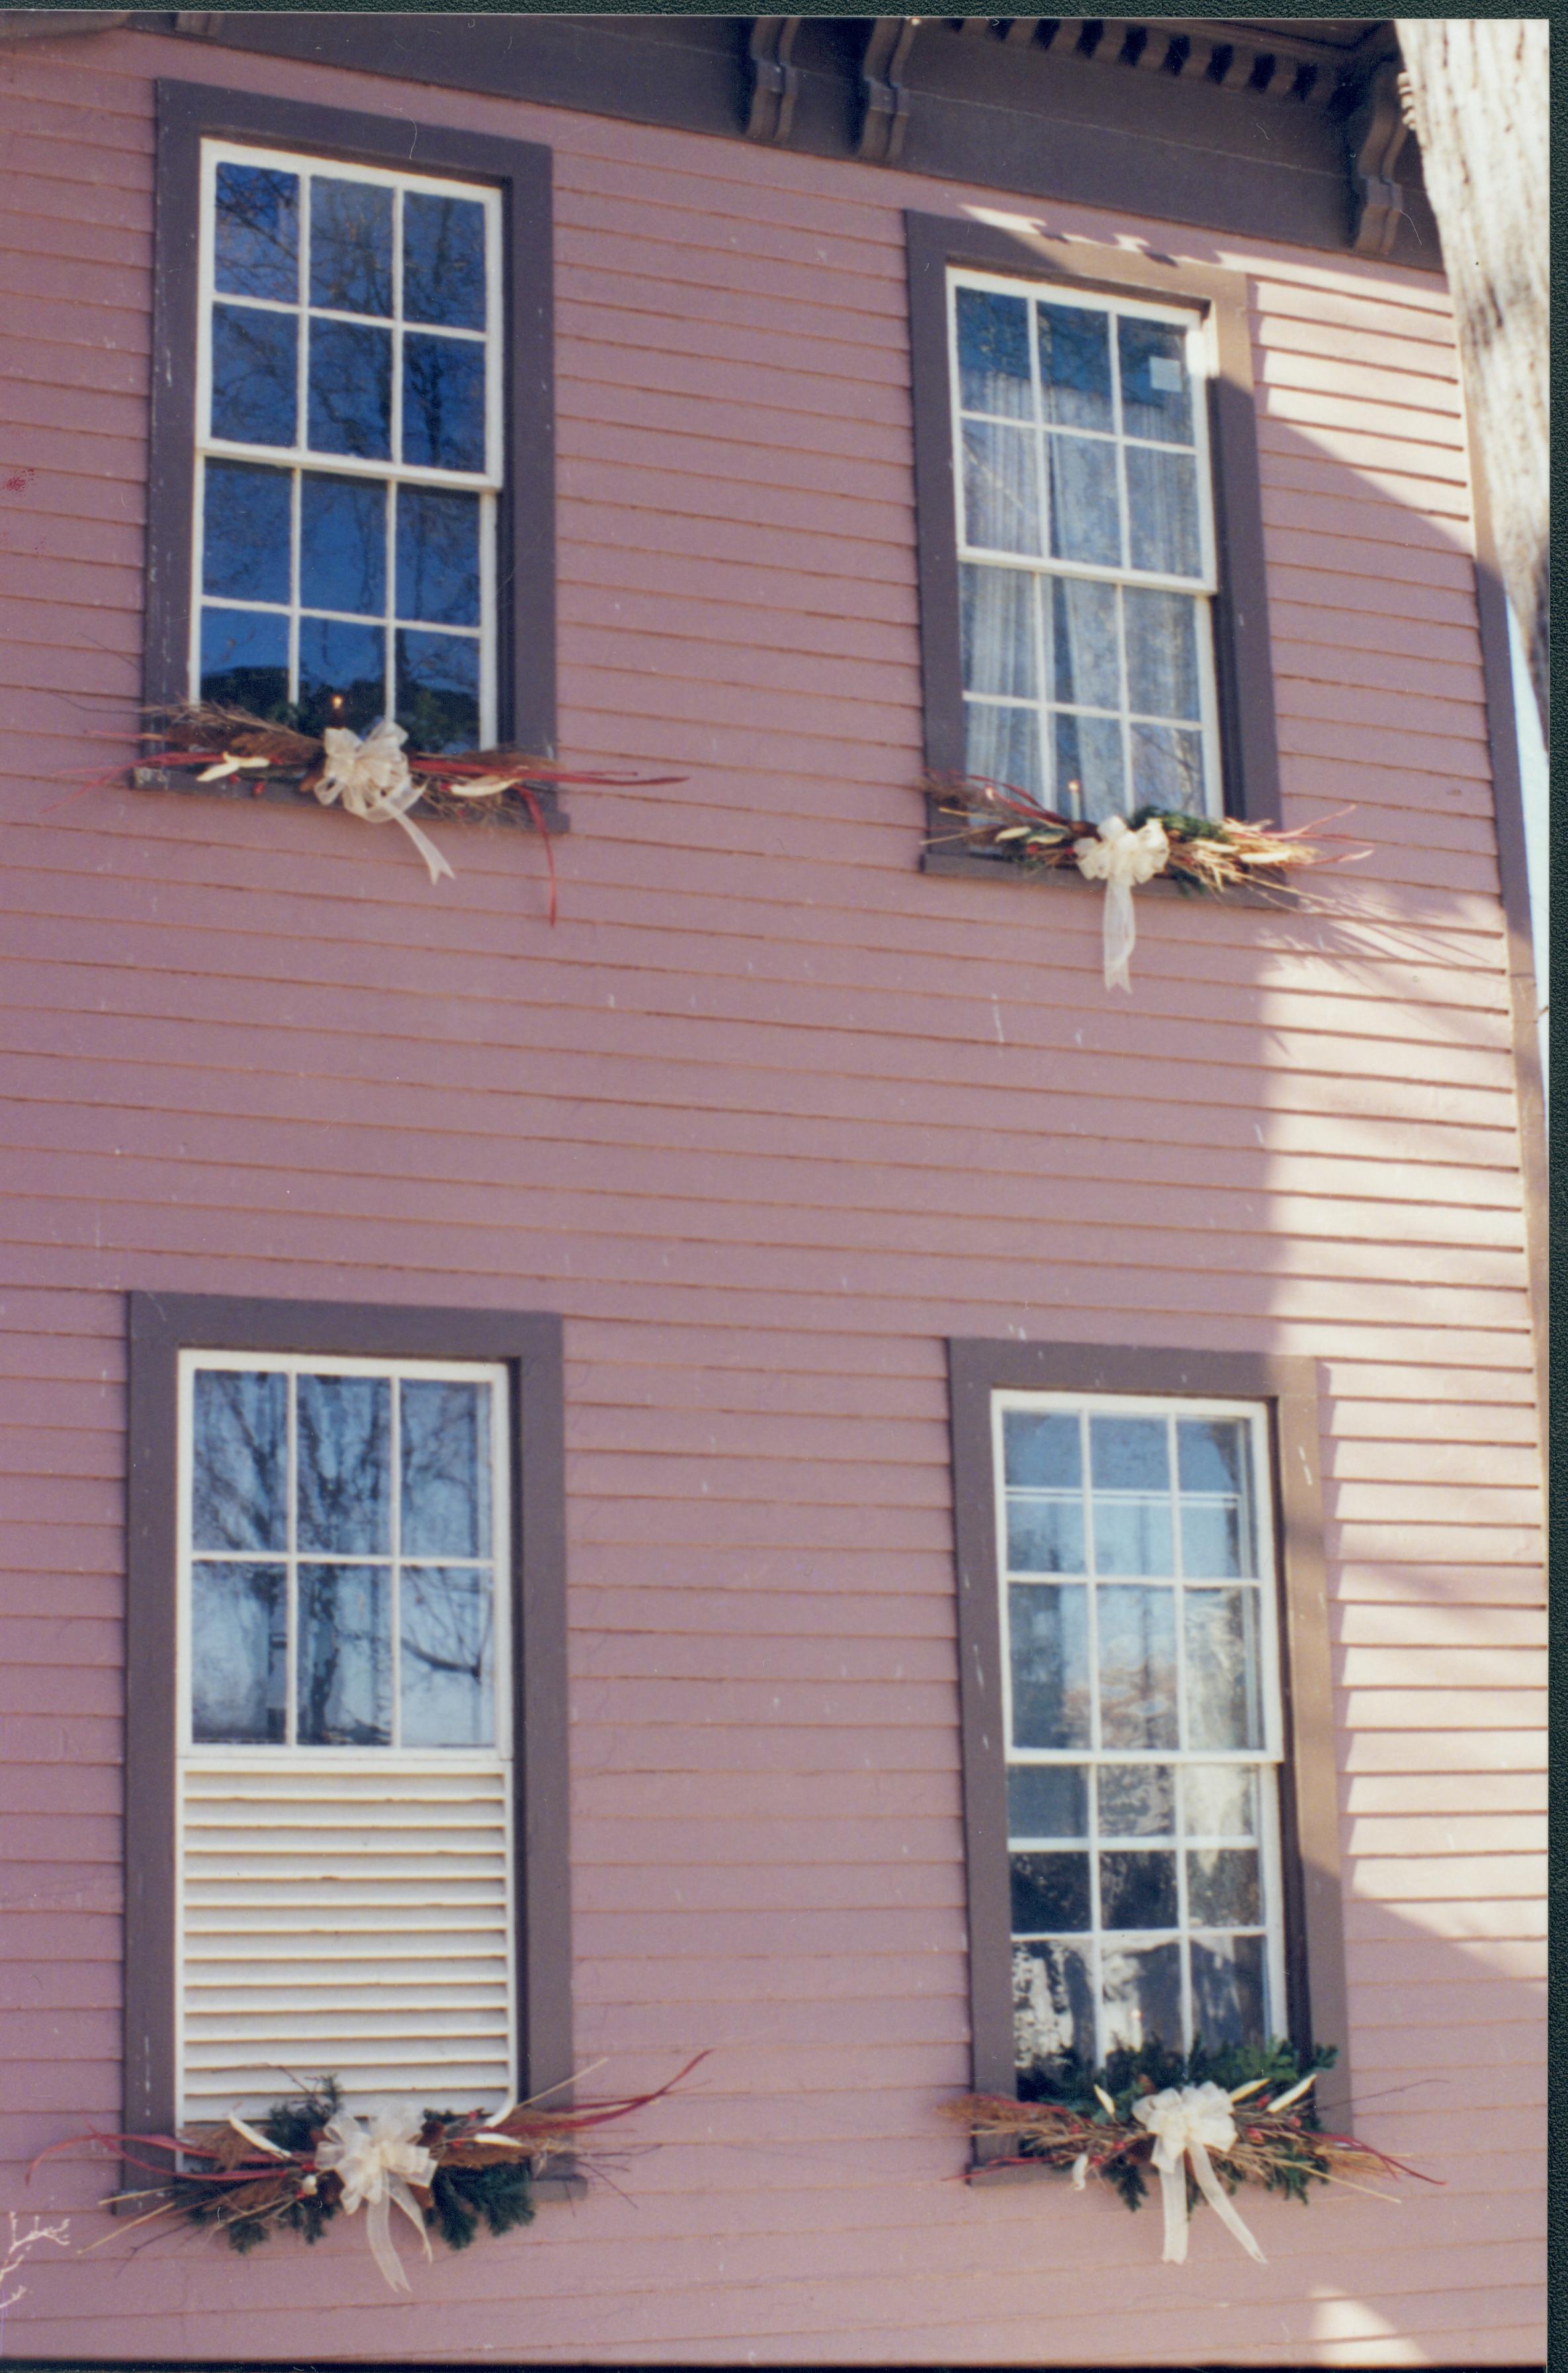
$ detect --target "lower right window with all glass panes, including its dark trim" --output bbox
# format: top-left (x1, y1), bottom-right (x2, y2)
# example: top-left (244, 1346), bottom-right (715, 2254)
top-left (949, 1341), bottom-right (1348, 2100)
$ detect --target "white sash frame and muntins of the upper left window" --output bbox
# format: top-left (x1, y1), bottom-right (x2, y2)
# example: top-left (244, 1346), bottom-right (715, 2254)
top-left (190, 135), bottom-right (505, 745)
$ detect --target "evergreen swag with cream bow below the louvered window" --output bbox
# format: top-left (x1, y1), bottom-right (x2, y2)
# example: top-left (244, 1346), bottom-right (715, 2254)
top-left (28, 2053), bottom-right (707, 2290)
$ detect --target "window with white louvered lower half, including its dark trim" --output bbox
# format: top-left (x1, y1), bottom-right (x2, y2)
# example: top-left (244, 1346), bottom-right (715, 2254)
top-left (126, 1296), bottom-right (572, 2131)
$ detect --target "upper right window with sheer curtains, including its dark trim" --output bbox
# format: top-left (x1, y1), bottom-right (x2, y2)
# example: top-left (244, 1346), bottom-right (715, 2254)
top-left (904, 214), bottom-right (1279, 880)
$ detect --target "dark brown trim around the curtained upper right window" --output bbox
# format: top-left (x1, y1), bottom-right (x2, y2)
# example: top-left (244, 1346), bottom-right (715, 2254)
top-left (904, 214), bottom-right (1279, 883)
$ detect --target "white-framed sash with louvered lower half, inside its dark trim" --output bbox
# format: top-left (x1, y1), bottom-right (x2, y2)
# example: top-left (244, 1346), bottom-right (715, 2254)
top-left (175, 1355), bottom-right (517, 2119)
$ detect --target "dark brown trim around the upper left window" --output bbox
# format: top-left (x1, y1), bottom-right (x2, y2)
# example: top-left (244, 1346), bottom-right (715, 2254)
top-left (145, 81), bottom-right (555, 797)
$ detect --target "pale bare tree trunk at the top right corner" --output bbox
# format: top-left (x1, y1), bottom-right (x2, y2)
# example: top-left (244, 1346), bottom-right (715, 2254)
top-left (1397, 17), bottom-right (1549, 733)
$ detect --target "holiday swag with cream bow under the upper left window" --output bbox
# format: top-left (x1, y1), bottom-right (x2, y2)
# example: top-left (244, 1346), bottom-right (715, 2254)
top-left (142, 700), bottom-right (683, 920)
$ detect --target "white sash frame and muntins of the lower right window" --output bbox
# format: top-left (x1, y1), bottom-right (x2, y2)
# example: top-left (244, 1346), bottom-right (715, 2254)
top-left (992, 1388), bottom-right (1288, 2067)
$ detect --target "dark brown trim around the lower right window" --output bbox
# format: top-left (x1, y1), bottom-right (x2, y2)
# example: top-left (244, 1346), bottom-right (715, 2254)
top-left (947, 1339), bottom-right (1350, 2159)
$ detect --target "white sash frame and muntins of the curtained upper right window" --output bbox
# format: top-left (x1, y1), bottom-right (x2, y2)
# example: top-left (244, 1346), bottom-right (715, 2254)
top-left (947, 263), bottom-right (1224, 817)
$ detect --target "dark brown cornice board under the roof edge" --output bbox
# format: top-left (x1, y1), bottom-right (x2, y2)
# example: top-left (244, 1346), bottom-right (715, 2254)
top-left (116, 9), bottom-right (1442, 271)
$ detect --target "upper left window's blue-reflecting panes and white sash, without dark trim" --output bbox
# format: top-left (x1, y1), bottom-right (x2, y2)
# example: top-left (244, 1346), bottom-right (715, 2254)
top-left (190, 140), bottom-right (503, 750)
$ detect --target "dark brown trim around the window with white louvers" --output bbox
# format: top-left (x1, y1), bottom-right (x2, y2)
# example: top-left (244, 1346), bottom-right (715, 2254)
top-left (126, 1293), bottom-right (574, 2164)
